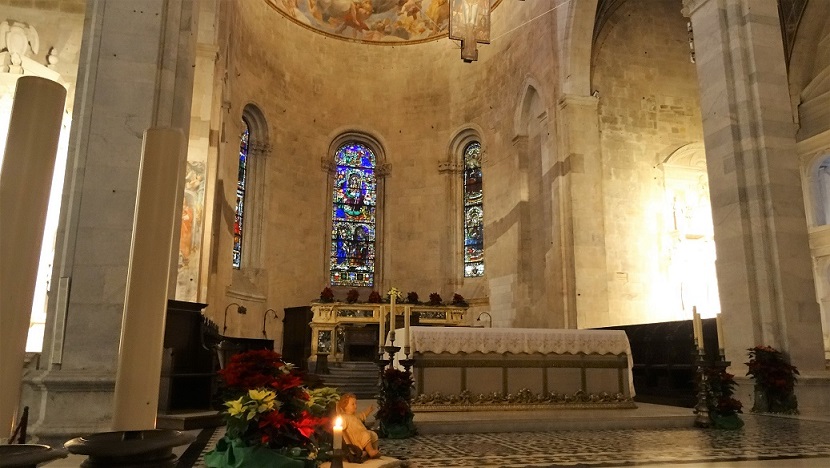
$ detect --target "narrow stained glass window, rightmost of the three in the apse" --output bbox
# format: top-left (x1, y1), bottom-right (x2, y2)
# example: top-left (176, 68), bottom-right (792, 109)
top-left (464, 141), bottom-right (484, 278)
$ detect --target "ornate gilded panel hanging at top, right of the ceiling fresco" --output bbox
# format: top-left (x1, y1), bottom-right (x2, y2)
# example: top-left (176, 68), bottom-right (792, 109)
top-left (450, 0), bottom-right (490, 63)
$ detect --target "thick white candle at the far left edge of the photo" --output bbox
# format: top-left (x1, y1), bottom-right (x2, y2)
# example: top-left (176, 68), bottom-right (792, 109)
top-left (0, 76), bottom-right (66, 438)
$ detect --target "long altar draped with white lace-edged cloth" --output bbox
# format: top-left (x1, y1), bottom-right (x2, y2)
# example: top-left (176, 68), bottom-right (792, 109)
top-left (404, 326), bottom-right (636, 411)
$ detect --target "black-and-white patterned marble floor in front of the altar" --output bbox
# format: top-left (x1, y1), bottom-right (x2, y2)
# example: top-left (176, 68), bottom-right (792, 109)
top-left (187, 414), bottom-right (830, 468)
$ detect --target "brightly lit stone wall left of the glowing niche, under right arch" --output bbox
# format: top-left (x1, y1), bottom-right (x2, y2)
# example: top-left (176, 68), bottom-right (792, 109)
top-left (596, 0), bottom-right (703, 327)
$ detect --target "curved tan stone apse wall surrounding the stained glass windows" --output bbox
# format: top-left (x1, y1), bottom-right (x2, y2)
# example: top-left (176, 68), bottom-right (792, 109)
top-left (207, 1), bottom-right (556, 336)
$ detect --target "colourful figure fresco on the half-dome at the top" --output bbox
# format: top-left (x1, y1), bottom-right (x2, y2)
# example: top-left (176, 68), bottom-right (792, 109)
top-left (265, 0), bottom-right (501, 45)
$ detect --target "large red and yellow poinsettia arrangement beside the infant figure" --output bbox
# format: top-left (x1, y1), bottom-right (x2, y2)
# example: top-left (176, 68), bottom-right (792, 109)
top-left (205, 350), bottom-right (338, 468)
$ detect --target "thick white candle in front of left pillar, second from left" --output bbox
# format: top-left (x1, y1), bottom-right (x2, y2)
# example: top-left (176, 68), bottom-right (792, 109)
top-left (112, 128), bottom-right (187, 431)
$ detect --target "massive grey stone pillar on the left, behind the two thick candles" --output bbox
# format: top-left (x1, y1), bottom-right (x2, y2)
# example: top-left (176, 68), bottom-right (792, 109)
top-left (24, 0), bottom-right (196, 441)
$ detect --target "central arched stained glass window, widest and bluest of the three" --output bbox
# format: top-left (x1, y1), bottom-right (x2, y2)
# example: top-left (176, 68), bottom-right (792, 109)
top-left (330, 142), bottom-right (377, 286)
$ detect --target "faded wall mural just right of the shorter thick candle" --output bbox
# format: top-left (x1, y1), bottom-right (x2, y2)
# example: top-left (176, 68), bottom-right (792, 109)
top-left (176, 161), bottom-right (205, 301)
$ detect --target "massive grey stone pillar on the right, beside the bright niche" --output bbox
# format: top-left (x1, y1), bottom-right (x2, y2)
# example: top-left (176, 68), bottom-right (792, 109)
top-left (683, 0), bottom-right (824, 375)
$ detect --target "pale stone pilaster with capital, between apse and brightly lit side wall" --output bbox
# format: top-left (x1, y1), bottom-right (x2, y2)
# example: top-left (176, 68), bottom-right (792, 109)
top-left (557, 95), bottom-right (610, 328)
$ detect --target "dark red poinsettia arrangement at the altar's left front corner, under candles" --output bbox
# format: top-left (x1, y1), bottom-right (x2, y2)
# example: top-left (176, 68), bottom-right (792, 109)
top-left (375, 367), bottom-right (416, 439)
